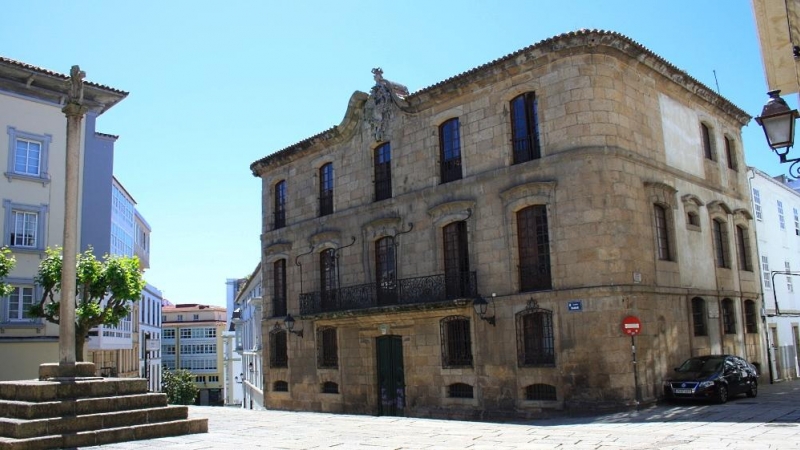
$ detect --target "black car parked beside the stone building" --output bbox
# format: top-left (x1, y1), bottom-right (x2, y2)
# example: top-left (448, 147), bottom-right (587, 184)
top-left (664, 355), bottom-right (758, 403)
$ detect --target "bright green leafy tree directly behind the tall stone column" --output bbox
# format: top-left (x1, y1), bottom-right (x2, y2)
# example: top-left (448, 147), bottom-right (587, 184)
top-left (30, 248), bottom-right (145, 361)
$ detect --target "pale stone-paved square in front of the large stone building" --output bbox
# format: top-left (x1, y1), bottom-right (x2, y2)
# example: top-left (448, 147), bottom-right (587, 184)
top-left (89, 381), bottom-right (800, 450)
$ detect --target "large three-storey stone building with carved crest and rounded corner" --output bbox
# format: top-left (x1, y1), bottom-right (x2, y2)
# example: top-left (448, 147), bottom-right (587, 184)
top-left (251, 31), bottom-right (763, 418)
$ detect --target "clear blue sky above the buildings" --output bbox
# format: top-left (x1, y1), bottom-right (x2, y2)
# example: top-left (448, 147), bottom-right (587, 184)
top-left (0, 0), bottom-right (796, 305)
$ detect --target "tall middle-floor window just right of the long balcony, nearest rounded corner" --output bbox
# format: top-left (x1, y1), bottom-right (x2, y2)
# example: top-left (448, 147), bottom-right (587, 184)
top-left (517, 205), bottom-right (552, 292)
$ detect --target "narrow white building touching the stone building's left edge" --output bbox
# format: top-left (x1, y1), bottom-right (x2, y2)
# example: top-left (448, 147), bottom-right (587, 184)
top-left (234, 263), bottom-right (264, 409)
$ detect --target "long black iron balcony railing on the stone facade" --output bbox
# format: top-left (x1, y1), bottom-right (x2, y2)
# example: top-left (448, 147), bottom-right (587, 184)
top-left (300, 272), bottom-right (478, 314)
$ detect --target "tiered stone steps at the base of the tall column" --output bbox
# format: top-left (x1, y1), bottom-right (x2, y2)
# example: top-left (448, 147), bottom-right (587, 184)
top-left (0, 377), bottom-right (208, 450)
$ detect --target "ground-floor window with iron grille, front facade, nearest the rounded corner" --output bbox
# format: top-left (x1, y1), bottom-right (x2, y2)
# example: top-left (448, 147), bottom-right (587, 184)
top-left (517, 306), bottom-right (556, 367)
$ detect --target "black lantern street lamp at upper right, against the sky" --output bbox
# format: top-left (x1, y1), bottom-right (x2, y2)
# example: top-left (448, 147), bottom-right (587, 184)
top-left (756, 90), bottom-right (800, 174)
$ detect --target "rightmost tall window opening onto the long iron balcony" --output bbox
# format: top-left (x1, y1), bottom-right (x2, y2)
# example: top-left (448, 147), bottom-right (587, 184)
top-left (442, 221), bottom-right (471, 299)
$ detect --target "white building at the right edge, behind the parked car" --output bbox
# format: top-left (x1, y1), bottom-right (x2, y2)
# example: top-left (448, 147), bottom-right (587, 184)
top-left (749, 167), bottom-right (800, 380)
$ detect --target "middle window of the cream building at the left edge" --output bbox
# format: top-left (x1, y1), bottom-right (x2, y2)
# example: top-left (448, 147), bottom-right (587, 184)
top-left (3, 200), bottom-right (47, 251)
